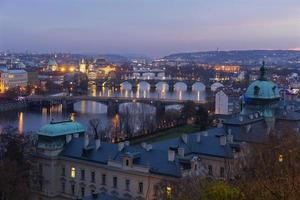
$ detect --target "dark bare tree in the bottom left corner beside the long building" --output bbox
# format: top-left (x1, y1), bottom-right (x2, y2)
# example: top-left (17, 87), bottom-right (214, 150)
top-left (0, 129), bottom-right (30, 200)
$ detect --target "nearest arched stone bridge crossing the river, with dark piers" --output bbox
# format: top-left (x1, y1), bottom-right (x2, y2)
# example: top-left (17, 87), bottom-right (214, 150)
top-left (26, 95), bottom-right (206, 115)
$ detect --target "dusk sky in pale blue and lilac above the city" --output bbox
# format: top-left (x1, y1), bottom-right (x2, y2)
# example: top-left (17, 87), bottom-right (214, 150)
top-left (0, 0), bottom-right (300, 56)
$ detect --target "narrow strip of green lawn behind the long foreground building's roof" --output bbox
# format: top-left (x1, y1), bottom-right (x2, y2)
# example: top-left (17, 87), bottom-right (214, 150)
top-left (130, 124), bottom-right (200, 144)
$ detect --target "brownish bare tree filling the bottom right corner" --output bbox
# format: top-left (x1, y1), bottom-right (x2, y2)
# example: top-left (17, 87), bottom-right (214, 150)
top-left (236, 126), bottom-right (300, 200)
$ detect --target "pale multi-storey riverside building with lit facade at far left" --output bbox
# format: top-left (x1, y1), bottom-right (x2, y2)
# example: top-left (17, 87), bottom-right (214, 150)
top-left (8, 69), bottom-right (28, 88)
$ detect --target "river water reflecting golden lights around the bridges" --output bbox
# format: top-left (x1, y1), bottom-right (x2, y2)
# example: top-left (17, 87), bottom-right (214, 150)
top-left (0, 82), bottom-right (206, 133)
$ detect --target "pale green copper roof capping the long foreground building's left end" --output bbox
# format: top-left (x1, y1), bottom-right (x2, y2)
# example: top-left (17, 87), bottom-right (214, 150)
top-left (38, 121), bottom-right (85, 137)
